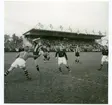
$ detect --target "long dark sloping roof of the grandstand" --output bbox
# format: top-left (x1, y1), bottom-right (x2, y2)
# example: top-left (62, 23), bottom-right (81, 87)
top-left (23, 28), bottom-right (104, 39)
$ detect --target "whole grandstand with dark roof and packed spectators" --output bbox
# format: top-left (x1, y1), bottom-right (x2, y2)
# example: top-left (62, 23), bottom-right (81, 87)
top-left (23, 28), bottom-right (104, 51)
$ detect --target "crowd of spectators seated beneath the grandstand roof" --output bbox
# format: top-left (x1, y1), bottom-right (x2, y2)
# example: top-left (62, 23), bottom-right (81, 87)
top-left (30, 39), bottom-right (101, 52)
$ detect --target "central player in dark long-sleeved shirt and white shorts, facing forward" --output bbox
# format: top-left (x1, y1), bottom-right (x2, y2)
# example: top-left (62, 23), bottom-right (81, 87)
top-left (55, 47), bottom-right (71, 72)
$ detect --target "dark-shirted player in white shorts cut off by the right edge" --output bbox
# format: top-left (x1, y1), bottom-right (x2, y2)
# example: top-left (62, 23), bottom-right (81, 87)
top-left (98, 45), bottom-right (108, 71)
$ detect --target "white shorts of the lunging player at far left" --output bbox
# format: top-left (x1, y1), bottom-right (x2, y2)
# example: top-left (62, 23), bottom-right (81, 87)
top-left (11, 58), bottom-right (26, 68)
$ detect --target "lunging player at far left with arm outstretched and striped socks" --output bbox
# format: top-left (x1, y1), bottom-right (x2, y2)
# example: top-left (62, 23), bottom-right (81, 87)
top-left (4, 46), bottom-right (38, 80)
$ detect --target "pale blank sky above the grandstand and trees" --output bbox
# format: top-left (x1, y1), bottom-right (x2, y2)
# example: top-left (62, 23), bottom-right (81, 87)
top-left (4, 0), bottom-right (109, 36)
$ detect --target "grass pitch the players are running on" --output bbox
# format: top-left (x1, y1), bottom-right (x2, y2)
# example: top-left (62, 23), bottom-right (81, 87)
top-left (4, 52), bottom-right (108, 104)
